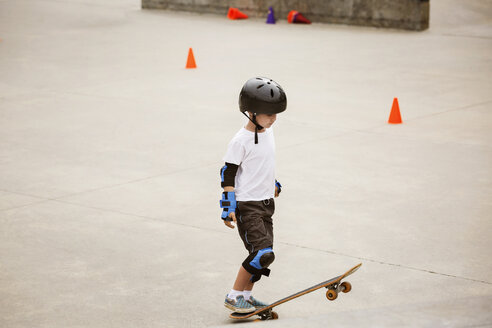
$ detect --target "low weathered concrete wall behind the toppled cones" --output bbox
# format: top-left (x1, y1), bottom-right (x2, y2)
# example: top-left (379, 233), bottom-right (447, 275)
top-left (142, 0), bottom-right (429, 31)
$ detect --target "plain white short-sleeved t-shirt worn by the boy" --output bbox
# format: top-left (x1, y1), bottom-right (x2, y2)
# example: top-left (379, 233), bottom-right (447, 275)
top-left (224, 128), bottom-right (275, 202)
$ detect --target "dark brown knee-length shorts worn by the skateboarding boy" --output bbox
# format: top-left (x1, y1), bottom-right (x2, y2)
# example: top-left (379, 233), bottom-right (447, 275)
top-left (236, 198), bottom-right (275, 254)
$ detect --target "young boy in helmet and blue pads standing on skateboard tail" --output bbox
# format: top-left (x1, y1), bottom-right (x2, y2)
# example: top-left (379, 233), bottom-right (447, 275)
top-left (220, 77), bottom-right (287, 313)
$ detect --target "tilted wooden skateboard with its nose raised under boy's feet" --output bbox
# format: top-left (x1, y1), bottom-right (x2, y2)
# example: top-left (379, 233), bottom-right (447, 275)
top-left (229, 263), bottom-right (362, 320)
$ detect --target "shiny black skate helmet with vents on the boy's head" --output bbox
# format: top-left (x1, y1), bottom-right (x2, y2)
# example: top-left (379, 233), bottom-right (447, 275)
top-left (239, 77), bottom-right (287, 114)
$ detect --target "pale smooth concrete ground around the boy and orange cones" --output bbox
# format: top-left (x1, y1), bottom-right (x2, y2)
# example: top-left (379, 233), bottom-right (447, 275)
top-left (0, 0), bottom-right (492, 327)
